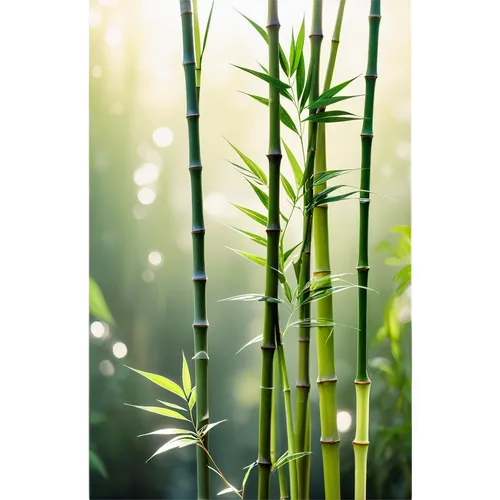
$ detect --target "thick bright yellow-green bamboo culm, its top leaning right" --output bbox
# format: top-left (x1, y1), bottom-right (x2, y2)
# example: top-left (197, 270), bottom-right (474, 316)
top-left (313, 0), bottom-right (346, 500)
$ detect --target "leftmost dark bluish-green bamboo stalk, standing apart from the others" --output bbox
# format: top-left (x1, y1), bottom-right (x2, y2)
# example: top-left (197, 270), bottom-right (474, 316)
top-left (180, 0), bottom-right (210, 500)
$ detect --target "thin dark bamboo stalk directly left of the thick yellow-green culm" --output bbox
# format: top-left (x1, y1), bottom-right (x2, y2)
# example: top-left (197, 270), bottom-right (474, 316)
top-left (296, 0), bottom-right (323, 500)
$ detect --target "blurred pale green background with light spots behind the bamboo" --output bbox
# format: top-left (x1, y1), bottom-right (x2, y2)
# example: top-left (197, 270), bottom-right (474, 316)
top-left (88, 0), bottom-right (412, 500)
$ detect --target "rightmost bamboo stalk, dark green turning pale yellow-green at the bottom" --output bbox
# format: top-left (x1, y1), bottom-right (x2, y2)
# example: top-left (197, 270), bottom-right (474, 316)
top-left (353, 0), bottom-right (381, 500)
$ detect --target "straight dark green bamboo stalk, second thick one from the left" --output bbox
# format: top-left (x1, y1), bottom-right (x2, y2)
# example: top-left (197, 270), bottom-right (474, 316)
top-left (258, 0), bottom-right (282, 500)
